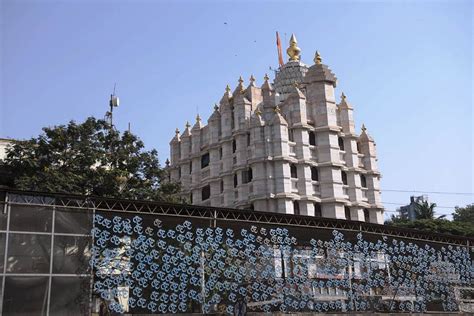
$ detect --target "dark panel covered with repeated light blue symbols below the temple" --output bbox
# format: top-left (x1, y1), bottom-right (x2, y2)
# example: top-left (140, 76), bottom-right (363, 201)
top-left (90, 214), bottom-right (473, 313)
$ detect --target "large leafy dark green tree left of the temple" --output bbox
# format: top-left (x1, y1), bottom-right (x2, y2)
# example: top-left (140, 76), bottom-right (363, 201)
top-left (0, 117), bottom-right (180, 201)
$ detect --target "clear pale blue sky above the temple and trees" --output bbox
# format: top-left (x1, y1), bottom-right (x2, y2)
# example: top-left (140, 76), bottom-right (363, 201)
top-left (0, 0), bottom-right (474, 214)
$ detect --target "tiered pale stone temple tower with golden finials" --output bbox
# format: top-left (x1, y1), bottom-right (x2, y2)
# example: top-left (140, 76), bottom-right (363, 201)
top-left (169, 35), bottom-right (383, 223)
